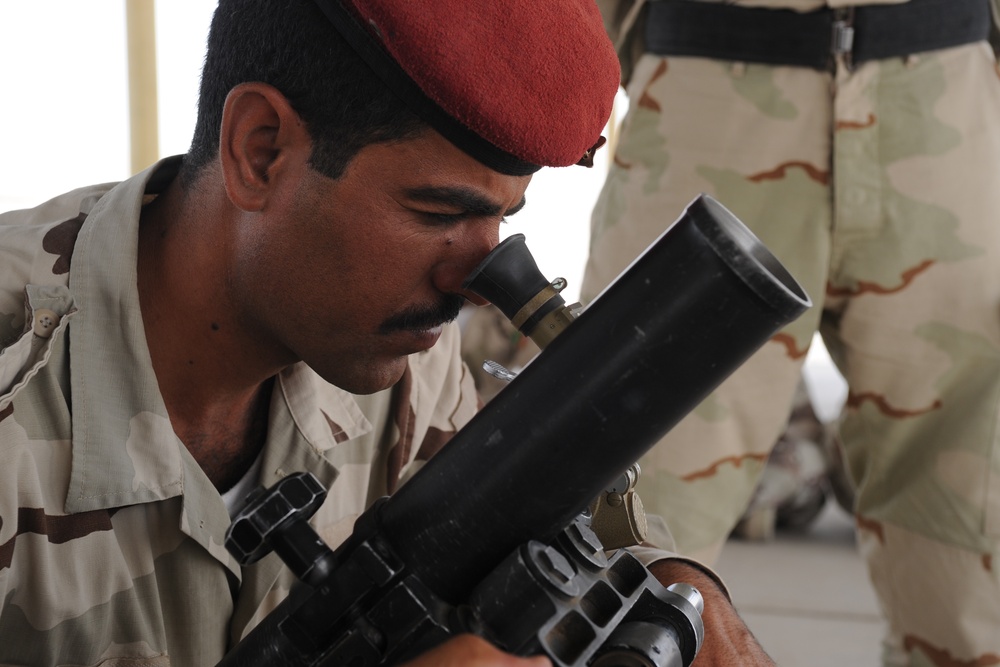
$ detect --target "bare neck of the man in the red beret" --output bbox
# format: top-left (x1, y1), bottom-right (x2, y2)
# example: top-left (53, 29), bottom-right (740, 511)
top-left (138, 174), bottom-right (287, 489)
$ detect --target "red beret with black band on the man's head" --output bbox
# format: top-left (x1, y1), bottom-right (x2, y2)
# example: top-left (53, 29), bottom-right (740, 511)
top-left (316, 0), bottom-right (620, 175)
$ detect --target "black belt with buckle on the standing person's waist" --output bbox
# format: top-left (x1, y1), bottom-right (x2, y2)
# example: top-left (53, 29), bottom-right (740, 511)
top-left (646, 0), bottom-right (991, 71)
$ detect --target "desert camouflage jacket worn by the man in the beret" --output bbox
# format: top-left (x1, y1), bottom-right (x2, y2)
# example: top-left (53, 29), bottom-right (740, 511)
top-left (0, 158), bottom-right (476, 667)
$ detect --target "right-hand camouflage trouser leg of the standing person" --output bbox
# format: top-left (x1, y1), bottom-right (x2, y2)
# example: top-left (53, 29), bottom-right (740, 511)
top-left (824, 44), bottom-right (1000, 666)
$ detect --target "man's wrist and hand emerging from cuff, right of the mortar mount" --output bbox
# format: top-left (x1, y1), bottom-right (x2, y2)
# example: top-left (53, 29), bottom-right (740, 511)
top-left (649, 560), bottom-right (774, 667)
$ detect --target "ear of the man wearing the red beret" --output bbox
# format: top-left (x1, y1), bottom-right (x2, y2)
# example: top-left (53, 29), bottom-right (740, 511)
top-left (219, 83), bottom-right (311, 211)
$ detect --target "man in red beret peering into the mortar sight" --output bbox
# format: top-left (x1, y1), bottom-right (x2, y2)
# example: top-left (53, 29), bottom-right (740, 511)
top-left (0, 0), bottom-right (769, 667)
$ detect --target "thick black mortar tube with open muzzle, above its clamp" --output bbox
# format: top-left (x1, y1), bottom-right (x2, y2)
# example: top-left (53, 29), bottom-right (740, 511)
top-left (379, 195), bottom-right (811, 603)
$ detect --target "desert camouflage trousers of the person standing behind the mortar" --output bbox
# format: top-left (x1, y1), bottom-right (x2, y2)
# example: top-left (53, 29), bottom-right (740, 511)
top-left (583, 44), bottom-right (1000, 665)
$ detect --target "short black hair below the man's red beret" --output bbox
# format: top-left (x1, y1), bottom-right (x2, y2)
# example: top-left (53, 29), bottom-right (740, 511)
top-left (183, 0), bottom-right (427, 182)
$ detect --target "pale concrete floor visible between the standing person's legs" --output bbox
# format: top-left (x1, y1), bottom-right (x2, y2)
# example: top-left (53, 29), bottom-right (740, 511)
top-left (715, 502), bottom-right (883, 667)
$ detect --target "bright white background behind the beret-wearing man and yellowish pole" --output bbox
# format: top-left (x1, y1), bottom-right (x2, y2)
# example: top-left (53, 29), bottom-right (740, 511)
top-left (0, 0), bottom-right (608, 301)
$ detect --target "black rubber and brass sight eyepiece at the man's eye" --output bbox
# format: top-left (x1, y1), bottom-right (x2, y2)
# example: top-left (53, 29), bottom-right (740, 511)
top-left (462, 234), bottom-right (574, 348)
